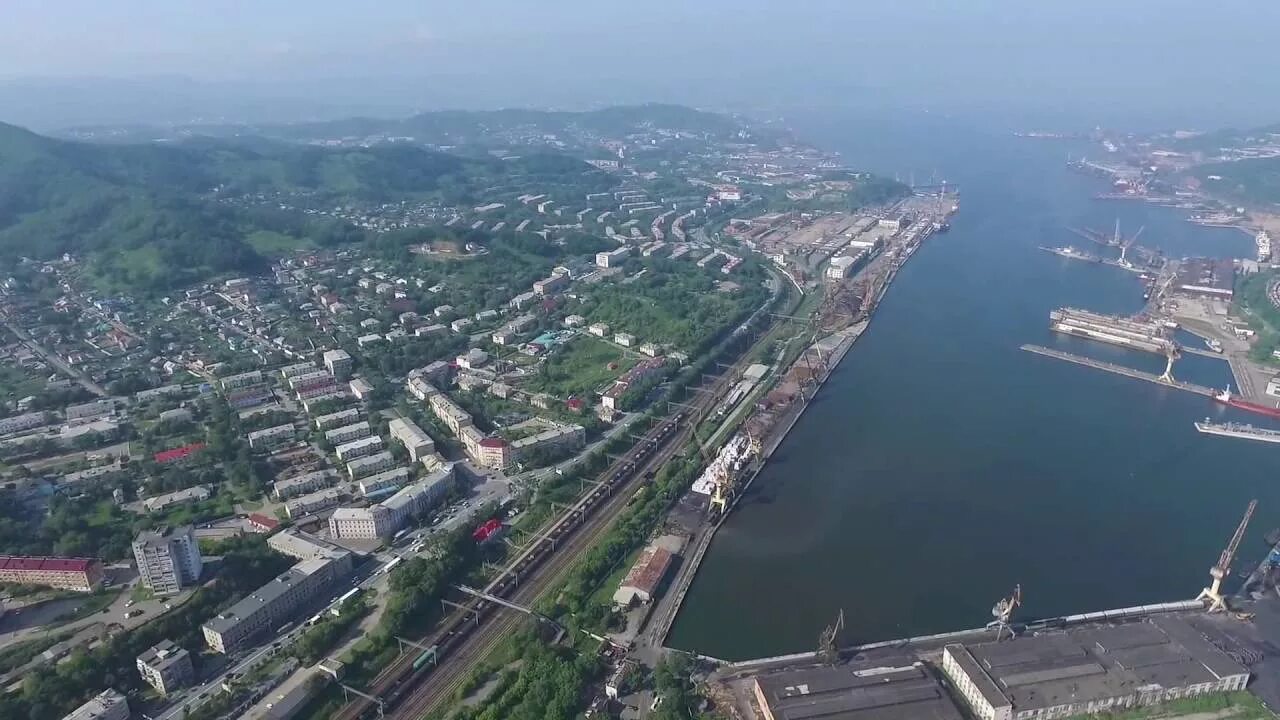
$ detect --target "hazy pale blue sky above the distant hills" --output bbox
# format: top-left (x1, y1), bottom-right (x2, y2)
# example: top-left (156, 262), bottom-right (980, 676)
top-left (0, 0), bottom-right (1280, 126)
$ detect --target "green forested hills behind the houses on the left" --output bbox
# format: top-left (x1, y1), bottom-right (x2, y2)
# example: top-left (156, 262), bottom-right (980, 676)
top-left (0, 124), bottom-right (613, 290)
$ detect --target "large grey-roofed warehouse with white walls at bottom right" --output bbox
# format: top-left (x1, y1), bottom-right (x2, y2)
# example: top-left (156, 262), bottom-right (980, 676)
top-left (942, 616), bottom-right (1249, 720)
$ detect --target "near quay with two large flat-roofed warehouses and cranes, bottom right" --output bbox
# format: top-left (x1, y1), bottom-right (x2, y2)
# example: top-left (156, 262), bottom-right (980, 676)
top-left (704, 501), bottom-right (1280, 720)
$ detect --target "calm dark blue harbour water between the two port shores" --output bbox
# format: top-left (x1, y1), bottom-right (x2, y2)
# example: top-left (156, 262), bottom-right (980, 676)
top-left (669, 110), bottom-right (1280, 659)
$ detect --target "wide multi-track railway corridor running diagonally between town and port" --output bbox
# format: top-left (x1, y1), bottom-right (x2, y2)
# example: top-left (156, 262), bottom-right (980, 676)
top-left (333, 278), bottom-right (777, 720)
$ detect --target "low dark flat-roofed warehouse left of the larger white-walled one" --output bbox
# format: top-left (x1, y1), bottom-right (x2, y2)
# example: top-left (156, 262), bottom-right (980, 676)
top-left (753, 662), bottom-right (964, 720)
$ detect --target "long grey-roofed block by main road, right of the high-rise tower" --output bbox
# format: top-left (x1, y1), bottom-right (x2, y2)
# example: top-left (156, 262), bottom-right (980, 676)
top-left (201, 557), bottom-right (343, 653)
